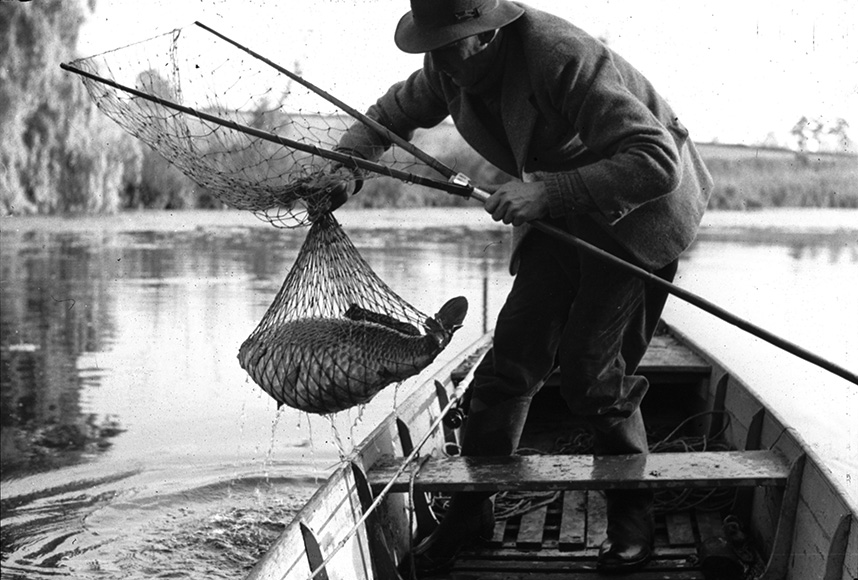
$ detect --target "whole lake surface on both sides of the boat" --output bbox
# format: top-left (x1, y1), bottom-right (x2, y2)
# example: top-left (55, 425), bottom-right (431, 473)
top-left (0, 208), bottom-right (858, 579)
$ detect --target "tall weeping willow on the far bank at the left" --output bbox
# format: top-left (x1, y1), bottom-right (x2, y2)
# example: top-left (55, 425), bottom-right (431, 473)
top-left (0, 0), bottom-right (142, 214)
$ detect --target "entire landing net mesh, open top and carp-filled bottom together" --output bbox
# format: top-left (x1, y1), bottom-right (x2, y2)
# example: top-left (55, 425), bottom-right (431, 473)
top-left (63, 26), bottom-right (467, 413)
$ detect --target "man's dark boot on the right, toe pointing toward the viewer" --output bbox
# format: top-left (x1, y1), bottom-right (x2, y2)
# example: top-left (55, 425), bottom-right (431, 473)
top-left (595, 409), bottom-right (654, 574)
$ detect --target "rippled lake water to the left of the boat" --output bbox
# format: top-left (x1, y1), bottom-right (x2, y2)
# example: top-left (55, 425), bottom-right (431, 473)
top-left (0, 213), bottom-right (507, 578)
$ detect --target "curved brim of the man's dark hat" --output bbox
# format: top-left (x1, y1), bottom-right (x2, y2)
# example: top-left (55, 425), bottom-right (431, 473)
top-left (393, 0), bottom-right (524, 54)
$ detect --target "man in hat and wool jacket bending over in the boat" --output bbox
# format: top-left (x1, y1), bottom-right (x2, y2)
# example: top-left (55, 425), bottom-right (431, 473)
top-left (328, 0), bottom-right (711, 574)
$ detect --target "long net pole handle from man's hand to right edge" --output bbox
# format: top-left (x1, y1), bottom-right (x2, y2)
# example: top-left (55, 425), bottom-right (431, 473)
top-left (471, 187), bottom-right (858, 385)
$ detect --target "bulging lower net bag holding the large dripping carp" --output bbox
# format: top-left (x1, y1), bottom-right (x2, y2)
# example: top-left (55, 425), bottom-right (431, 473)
top-left (238, 214), bottom-right (467, 414)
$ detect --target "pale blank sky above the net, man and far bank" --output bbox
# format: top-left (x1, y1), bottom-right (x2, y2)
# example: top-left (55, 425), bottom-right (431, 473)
top-left (78, 0), bottom-right (858, 144)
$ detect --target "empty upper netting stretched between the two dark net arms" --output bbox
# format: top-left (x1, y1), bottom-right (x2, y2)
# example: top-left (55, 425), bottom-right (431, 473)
top-left (69, 26), bottom-right (431, 227)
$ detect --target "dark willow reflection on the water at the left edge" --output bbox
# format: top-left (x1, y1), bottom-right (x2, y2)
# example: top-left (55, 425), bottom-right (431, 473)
top-left (0, 229), bottom-right (121, 474)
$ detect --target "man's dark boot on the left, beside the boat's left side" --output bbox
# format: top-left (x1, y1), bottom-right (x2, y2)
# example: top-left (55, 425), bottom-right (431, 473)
top-left (399, 397), bottom-right (530, 578)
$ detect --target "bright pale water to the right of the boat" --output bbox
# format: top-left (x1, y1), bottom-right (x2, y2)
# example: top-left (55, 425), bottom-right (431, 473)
top-left (665, 218), bottom-right (858, 509)
